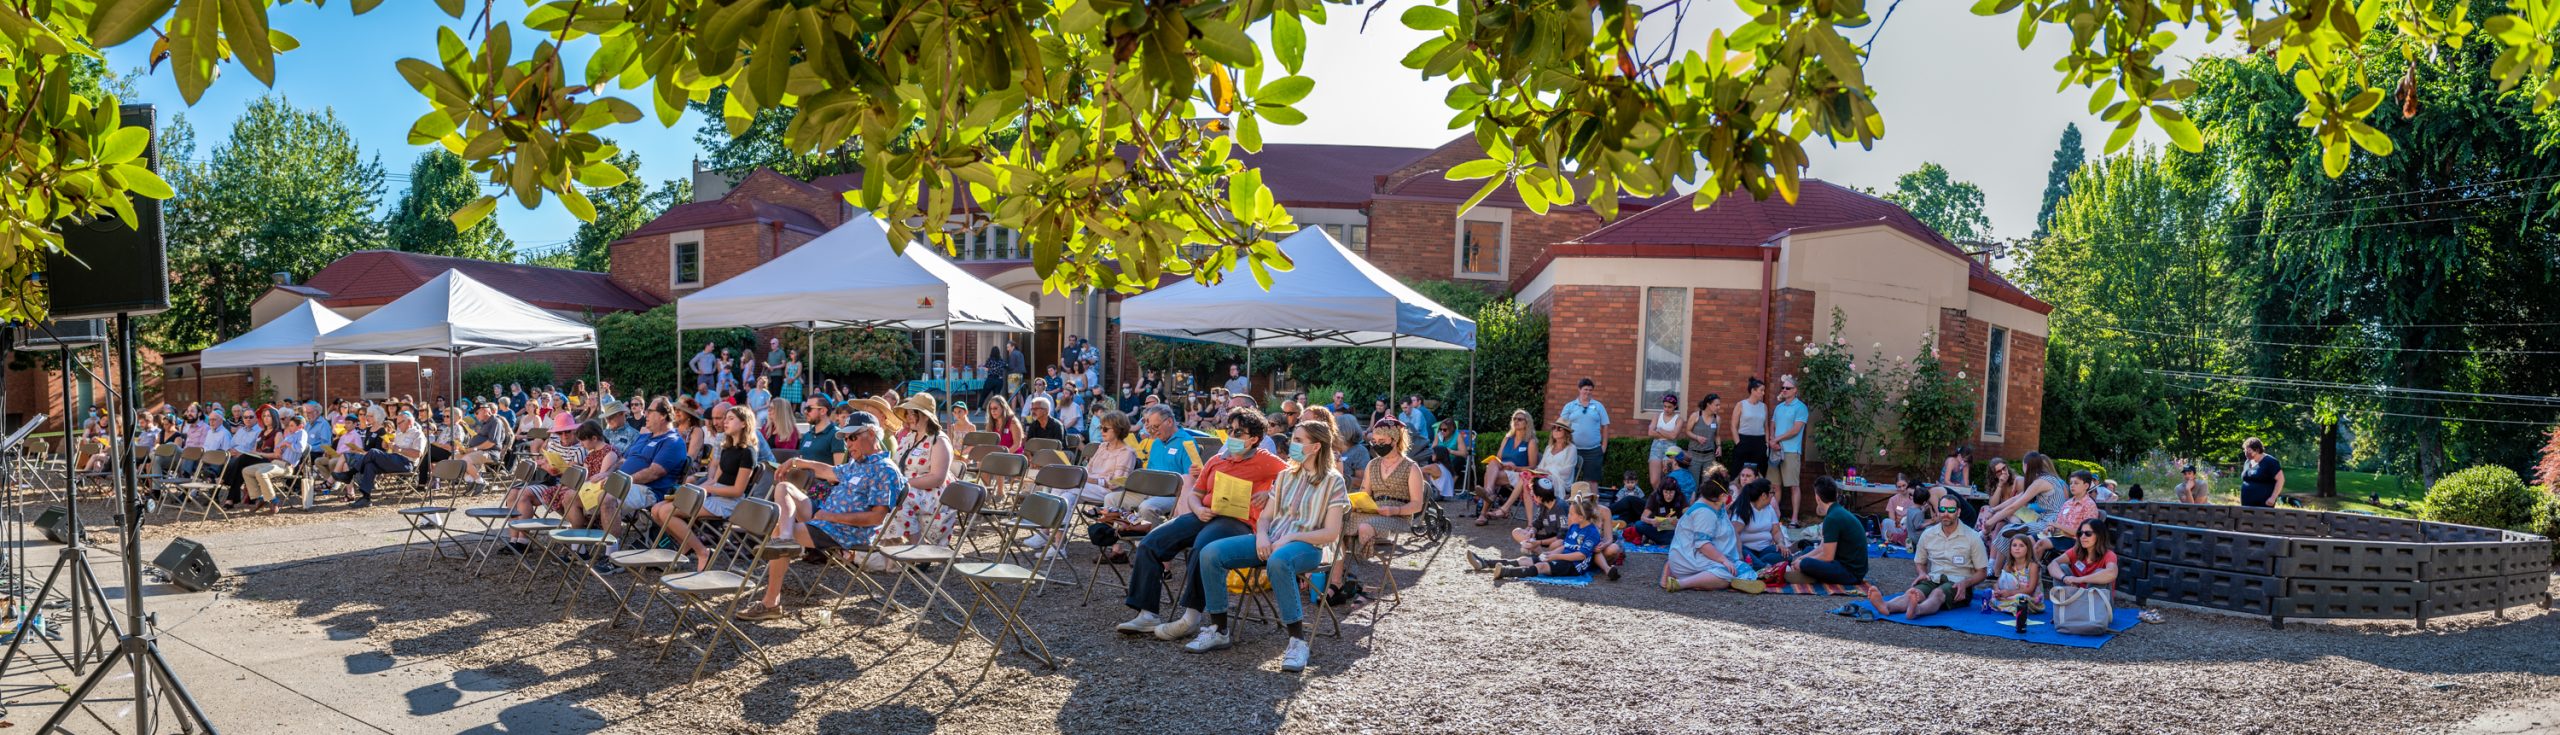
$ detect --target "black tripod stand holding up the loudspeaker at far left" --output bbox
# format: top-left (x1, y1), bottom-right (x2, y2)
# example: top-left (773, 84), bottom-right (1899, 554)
top-left (36, 312), bottom-right (220, 735)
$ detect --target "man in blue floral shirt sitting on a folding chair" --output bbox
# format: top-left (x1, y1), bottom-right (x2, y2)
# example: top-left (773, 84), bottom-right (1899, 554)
top-left (737, 410), bottom-right (906, 620)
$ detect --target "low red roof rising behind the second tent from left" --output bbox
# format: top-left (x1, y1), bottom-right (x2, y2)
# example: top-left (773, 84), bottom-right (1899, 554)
top-left (302, 251), bottom-right (658, 312)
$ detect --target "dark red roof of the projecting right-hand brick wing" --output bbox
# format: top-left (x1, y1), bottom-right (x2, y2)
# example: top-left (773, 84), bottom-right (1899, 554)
top-left (1531, 179), bottom-right (2053, 312)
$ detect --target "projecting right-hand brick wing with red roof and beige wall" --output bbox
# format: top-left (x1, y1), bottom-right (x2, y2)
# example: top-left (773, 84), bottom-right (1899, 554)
top-left (1513, 179), bottom-right (2053, 456)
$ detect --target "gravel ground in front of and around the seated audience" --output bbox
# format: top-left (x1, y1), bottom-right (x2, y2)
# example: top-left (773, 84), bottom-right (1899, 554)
top-left (215, 507), bottom-right (2560, 732)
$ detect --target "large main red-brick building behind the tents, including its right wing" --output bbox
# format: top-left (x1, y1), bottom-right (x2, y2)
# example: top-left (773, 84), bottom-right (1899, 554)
top-left (612, 138), bottom-right (2051, 456)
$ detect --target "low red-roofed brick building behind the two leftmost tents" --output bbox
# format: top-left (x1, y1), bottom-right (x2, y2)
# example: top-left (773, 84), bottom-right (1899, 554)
top-left (213, 251), bottom-right (666, 402)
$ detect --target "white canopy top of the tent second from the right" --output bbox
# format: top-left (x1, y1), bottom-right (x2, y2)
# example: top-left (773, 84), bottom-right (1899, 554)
top-left (676, 213), bottom-right (1032, 333)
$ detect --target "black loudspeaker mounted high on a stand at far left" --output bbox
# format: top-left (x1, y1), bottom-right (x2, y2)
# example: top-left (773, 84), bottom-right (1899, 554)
top-left (44, 105), bottom-right (169, 320)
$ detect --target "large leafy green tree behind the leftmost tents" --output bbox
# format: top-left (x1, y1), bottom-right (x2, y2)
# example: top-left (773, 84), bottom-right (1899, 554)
top-left (146, 95), bottom-right (384, 351)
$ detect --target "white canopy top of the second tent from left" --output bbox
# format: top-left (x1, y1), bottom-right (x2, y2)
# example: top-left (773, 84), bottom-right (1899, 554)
top-left (315, 269), bottom-right (596, 356)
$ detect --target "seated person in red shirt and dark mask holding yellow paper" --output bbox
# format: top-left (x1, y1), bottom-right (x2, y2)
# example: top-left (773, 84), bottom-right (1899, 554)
top-left (1119, 407), bottom-right (1288, 640)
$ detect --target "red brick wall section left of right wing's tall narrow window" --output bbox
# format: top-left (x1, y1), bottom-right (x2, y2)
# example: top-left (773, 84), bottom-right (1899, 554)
top-left (1536, 286), bottom-right (1644, 435)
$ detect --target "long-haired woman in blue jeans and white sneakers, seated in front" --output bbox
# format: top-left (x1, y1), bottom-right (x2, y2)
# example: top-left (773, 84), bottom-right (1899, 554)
top-left (1183, 420), bottom-right (1352, 671)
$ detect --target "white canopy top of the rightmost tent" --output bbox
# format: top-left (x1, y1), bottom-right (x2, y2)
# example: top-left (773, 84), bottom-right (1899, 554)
top-left (1121, 228), bottom-right (1475, 351)
